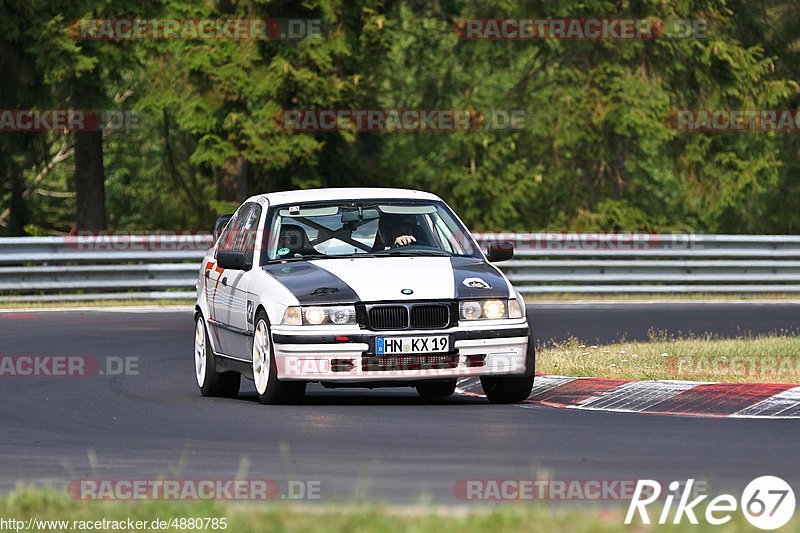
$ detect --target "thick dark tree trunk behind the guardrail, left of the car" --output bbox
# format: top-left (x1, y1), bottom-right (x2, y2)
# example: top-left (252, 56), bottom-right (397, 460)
top-left (75, 129), bottom-right (106, 231)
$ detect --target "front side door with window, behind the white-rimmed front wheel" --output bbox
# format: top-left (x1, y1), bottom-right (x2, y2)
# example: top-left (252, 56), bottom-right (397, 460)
top-left (217, 202), bottom-right (261, 360)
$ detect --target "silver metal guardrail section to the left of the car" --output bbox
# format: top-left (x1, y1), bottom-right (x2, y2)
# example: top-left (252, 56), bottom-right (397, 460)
top-left (0, 234), bottom-right (212, 302)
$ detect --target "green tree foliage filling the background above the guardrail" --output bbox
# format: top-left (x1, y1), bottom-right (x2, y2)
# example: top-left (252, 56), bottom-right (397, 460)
top-left (0, 0), bottom-right (800, 234)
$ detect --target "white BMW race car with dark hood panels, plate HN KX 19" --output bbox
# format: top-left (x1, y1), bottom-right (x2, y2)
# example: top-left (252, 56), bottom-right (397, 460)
top-left (194, 188), bottom-right (534, 403)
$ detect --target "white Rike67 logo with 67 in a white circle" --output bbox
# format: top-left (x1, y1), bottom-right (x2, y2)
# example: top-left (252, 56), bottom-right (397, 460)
top-left (625, 476), bottom-right (795, 530)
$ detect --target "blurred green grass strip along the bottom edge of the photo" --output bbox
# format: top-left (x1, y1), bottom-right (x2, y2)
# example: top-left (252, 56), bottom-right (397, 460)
top-left (0, 489), bottom-right (800, 533)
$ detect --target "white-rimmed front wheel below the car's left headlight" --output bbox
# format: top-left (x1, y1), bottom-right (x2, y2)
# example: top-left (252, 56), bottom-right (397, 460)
top-left (252, 311), bottom-right (306, 405)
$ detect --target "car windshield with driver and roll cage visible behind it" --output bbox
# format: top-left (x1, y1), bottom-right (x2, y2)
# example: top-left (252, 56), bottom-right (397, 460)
top-left (262, 200), bottom-right (480, 264)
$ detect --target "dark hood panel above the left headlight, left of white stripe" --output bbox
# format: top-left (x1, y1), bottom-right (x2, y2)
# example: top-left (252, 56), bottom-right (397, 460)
top-left (262, 261), bottom-right (358, 305)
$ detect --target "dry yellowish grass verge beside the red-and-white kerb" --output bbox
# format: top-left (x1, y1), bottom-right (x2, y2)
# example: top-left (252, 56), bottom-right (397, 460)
top-left (536, 333), bottom-right (800, 383)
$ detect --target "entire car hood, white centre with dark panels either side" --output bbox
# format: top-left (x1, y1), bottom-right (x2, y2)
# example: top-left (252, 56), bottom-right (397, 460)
top-left (263, 256), bottom-right (510, 305)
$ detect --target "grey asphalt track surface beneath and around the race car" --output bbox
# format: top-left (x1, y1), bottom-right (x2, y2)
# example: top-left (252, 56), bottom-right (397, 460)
top-left (0, 303), bottom-right (800, 504)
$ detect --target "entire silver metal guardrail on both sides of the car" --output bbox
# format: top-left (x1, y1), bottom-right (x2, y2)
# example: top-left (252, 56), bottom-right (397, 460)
top-left (0, 233), bottom-right (800, 302)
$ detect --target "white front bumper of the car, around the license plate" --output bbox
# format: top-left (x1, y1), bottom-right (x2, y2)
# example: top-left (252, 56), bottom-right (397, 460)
top-left (272, 319), bottom-right (529, 383)
